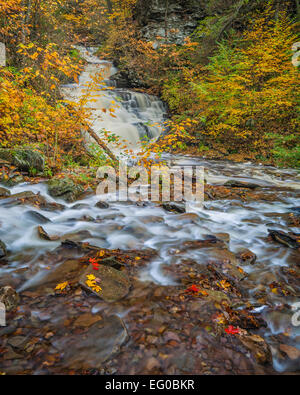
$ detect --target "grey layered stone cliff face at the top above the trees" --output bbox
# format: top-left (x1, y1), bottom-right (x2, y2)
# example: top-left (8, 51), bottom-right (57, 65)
top-left (135, 0), bottom-right (206, 44)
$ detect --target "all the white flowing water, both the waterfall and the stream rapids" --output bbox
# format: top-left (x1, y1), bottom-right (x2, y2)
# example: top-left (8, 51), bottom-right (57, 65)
top-left (0, 47), bottom-right (300, 371)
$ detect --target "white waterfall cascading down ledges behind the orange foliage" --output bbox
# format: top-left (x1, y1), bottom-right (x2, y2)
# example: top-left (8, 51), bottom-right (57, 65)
top-left (62, 46), bottom-right (166, 152)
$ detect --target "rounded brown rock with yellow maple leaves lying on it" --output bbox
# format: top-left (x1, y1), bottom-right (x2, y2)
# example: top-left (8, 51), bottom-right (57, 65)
top-left (80, 265), bottom-right (130, 302)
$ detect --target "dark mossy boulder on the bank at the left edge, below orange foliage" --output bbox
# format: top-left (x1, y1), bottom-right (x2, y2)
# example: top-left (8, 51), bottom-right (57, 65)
top-left (0, 148), bottom-right (45, 172)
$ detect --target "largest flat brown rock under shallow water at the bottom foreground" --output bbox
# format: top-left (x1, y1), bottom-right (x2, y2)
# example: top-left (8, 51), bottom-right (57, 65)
top-left (52, 315), bottom-right (128, 370)
